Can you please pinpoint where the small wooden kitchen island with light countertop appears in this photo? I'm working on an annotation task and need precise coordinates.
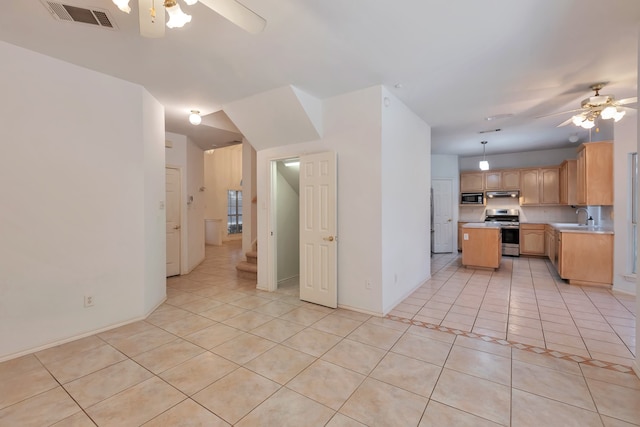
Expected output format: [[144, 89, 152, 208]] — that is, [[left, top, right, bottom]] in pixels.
[[462, 222, 502, 269]]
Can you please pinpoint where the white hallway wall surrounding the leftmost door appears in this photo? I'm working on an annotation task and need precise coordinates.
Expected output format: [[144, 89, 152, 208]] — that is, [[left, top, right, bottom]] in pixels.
[[165, 132, 206, 274]]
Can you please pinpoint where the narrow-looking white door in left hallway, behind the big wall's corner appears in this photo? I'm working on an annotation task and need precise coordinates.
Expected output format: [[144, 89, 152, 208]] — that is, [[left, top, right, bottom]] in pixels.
[[165, 168, 181, 277]]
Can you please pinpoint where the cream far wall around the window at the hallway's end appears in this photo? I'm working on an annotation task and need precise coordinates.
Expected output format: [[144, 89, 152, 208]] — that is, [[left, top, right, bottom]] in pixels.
[[204, 144, 242, 240]]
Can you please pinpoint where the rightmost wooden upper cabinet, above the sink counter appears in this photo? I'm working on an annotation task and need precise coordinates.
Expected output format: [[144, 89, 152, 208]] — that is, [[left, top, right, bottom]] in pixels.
[[576, 141, 613, 206]]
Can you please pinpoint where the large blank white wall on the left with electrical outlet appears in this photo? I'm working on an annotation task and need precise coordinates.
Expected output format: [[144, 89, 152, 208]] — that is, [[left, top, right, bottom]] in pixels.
[[0, 42, 166, 360]]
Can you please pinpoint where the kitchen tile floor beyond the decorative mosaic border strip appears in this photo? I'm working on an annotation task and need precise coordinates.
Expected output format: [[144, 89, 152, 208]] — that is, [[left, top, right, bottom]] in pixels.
[[389, 254, 636, 366]]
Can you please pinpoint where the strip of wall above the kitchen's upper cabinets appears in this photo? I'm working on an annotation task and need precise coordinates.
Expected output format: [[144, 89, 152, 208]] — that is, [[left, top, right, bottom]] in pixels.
[[459, 147, 580, 171]]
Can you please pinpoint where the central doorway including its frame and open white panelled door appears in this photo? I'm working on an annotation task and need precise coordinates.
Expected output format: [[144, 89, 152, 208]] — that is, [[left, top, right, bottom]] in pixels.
[[267, 152, 338, 308]]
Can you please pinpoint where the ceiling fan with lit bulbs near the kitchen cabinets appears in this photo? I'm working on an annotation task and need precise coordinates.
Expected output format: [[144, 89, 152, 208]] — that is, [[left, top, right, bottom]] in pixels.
[[540, 83, 638, 129]]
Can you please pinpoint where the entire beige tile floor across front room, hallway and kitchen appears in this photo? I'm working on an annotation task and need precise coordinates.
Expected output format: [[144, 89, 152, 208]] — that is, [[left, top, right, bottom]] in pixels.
[[0, 243, 640, 427]]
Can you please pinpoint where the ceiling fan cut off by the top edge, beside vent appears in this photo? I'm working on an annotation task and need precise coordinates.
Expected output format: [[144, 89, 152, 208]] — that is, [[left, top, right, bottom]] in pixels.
[[112, 0, 267, 38]]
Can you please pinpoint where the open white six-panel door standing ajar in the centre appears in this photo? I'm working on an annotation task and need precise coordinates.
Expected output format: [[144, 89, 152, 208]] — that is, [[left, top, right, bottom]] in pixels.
[[300, 152, 338, 308]]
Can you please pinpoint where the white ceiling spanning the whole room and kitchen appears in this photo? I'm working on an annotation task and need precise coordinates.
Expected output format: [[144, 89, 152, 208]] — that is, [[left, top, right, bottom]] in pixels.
[[0, 0, 640, 156]]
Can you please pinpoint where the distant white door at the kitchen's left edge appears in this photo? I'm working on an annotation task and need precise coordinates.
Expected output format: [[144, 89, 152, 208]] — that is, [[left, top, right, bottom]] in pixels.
[[431, 179, 453, 253]]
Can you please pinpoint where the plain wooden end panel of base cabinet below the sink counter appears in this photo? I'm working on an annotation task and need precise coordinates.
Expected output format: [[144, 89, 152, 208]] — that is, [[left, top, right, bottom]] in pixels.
[[557, 232, 613, 285]]
